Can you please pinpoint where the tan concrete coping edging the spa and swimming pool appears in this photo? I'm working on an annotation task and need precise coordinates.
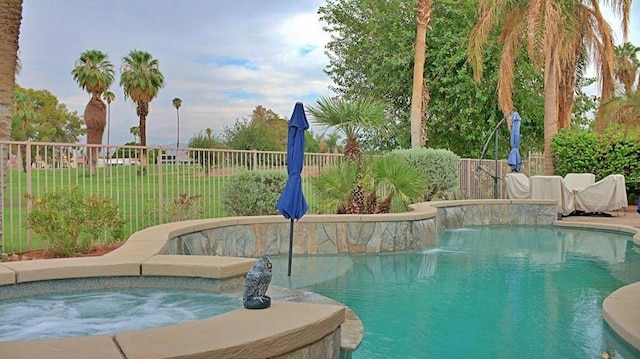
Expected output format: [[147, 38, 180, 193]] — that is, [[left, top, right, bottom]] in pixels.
[[0, 200, 640, 359]]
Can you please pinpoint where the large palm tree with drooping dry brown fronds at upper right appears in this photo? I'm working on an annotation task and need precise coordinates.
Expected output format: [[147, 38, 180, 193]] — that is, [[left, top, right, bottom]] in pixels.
[[468, 0, 630, 174]]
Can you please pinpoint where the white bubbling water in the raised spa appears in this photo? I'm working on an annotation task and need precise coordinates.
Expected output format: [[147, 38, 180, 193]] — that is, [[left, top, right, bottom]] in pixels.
[[0, 289, 242, 342]]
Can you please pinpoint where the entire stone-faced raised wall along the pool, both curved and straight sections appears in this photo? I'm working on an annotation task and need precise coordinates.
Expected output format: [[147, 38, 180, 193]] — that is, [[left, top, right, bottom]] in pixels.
[[165, 200, 556, 257]]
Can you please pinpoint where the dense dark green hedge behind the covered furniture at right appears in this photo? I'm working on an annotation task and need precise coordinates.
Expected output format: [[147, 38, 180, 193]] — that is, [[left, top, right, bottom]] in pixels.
[[552, 126, 640, 197]]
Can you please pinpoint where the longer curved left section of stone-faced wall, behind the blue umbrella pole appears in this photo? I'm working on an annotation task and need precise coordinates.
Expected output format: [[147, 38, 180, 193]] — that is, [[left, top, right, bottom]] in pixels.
[[166, 218, 436, 257]]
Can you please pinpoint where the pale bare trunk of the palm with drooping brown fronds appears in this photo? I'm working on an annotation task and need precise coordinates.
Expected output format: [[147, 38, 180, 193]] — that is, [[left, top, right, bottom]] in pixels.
[[544, 49, 558, 176]]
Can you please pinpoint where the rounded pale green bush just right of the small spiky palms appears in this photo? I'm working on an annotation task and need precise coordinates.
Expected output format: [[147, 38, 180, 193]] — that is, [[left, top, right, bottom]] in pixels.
[[389, 148, 460, 201]]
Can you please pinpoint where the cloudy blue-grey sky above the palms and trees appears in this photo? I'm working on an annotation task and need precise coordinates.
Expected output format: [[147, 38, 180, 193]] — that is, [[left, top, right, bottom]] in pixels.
[[16, 0, 640, 146]]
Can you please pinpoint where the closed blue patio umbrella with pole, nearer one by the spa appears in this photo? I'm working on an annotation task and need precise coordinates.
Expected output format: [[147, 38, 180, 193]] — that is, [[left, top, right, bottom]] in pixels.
[[276, 102, 309, 276]]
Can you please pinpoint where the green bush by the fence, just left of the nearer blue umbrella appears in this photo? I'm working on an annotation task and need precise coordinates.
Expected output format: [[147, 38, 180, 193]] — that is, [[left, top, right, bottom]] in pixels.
[[222, 171, 287, 216]]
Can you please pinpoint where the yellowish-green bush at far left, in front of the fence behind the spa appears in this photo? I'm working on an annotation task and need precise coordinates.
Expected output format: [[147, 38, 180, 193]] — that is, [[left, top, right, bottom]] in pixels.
[[27, 187, 124, 257]]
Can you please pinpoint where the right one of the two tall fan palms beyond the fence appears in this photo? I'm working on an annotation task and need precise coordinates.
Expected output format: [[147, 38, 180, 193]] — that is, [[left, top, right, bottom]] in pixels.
[[120, 50, 164, 165]]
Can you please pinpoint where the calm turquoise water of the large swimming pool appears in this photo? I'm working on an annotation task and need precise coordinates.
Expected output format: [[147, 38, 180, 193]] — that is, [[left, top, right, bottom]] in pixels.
[[272, 226, 640, 359]]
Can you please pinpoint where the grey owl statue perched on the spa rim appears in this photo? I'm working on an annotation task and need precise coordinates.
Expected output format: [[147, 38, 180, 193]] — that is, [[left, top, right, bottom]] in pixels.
[[242, 256, 271, 309]]
